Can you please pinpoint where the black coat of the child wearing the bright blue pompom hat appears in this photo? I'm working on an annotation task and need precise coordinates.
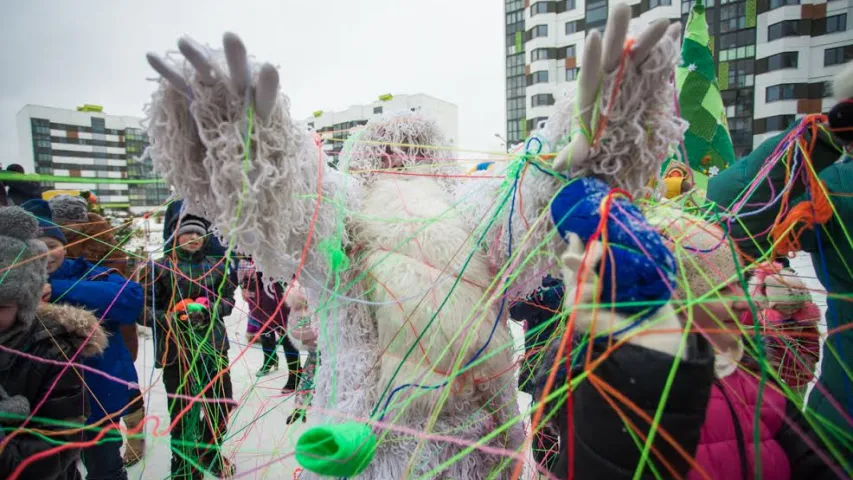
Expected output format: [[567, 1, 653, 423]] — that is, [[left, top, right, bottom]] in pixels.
[[534, 335, 714, 480]]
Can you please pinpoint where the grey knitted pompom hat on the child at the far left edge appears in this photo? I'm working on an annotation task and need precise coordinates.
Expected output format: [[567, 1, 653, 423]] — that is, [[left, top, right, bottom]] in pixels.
[[0, 206, 47, 327]]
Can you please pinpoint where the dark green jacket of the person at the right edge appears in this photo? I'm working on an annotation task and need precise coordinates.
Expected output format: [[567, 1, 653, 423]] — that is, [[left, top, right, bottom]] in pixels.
[[707, 126, 853, 451]]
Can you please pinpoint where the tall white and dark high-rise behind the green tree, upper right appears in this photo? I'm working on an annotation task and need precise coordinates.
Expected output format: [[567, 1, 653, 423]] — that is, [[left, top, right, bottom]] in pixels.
[[505, 0, 853, 156]]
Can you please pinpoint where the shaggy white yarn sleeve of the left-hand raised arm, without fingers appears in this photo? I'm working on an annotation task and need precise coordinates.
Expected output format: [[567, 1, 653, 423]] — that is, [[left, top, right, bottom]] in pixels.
[[148, 53, 357, 281]]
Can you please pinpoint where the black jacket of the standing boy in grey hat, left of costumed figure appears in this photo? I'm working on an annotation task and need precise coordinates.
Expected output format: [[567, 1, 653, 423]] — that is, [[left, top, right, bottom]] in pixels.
[[142, 248, 237, 368]]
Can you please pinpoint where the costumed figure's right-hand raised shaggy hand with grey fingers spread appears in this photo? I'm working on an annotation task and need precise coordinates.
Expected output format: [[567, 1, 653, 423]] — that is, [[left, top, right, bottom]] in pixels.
[[554, 4, 685, 194]]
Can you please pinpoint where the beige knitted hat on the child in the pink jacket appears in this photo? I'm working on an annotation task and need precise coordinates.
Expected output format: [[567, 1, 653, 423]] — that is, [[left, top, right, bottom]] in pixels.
[[646, 205, 740, 300]]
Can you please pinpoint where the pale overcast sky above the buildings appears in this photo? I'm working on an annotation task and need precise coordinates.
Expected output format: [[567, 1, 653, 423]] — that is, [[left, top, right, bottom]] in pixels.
[[0, 0, 506, 165]]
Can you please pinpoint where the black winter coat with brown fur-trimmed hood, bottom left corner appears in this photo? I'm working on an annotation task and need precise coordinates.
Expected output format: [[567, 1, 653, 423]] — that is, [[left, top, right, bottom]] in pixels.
[[0, 304, 107, 480]]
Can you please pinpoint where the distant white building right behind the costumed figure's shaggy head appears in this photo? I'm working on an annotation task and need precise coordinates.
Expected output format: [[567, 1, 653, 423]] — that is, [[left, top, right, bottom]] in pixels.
[[305, 93, 459, 164]]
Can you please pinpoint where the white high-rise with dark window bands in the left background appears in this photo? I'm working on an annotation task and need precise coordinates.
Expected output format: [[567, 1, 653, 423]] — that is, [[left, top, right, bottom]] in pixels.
[[17, 105, 169, 213]]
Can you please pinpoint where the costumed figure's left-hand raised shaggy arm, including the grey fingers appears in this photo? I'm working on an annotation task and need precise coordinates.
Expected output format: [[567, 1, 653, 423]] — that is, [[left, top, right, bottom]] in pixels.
[[147, 33, 342, 281]]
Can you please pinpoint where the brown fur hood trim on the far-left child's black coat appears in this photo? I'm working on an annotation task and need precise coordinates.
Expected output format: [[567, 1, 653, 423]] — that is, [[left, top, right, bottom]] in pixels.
[[33, 303, 108, 357]]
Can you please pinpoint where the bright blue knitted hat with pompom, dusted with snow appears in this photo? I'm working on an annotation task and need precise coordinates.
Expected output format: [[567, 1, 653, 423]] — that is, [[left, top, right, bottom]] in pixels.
[[551, 177, 677, 316]]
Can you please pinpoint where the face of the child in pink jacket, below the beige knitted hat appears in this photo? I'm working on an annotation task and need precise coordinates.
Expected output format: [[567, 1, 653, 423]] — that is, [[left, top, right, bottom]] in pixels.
[[690, 281, 749, 348]]
